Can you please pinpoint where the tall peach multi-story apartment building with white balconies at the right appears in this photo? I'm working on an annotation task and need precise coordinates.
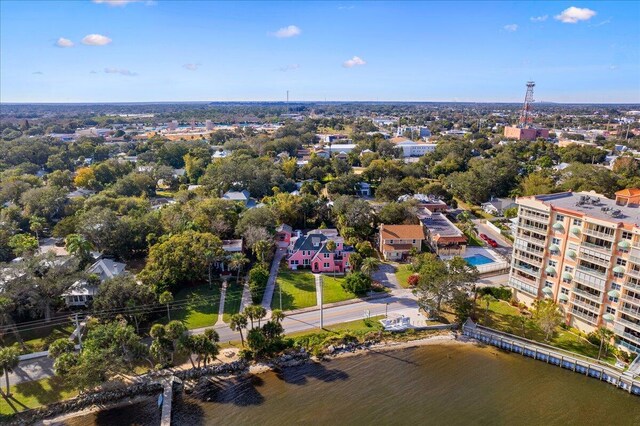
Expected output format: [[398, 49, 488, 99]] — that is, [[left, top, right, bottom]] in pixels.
[[509, 189, 640, 353]]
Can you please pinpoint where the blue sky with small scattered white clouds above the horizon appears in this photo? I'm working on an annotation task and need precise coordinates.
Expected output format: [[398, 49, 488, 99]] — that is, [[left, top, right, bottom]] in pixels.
[[0, 0, 640, 103]]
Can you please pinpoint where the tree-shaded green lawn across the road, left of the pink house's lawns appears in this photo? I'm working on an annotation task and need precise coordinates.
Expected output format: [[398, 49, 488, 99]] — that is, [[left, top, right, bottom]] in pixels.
[[162, 282, 220, 330]]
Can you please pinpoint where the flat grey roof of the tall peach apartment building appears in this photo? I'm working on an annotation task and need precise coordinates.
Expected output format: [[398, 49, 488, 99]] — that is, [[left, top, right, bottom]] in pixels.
[[525, 192, 640, 226]]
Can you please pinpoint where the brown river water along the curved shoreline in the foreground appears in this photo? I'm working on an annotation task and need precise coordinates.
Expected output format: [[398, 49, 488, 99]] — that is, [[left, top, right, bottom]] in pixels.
[[66, 345, 640, 426]]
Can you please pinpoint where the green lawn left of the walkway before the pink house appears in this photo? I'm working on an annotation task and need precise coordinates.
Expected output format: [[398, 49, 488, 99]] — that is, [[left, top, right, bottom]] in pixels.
[[271, 269, 316, 311]]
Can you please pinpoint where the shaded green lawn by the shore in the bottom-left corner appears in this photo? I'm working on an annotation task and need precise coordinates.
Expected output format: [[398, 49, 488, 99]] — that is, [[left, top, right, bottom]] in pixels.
[[0, 377, 78, 416]]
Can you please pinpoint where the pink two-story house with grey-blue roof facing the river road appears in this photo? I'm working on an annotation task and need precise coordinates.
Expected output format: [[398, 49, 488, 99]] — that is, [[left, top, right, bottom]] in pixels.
[[287, 229, 353, 273]]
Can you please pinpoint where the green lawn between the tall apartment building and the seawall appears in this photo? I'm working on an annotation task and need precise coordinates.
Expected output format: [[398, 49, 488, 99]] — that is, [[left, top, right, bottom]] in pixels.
[[478, 301, 615, 364]]
